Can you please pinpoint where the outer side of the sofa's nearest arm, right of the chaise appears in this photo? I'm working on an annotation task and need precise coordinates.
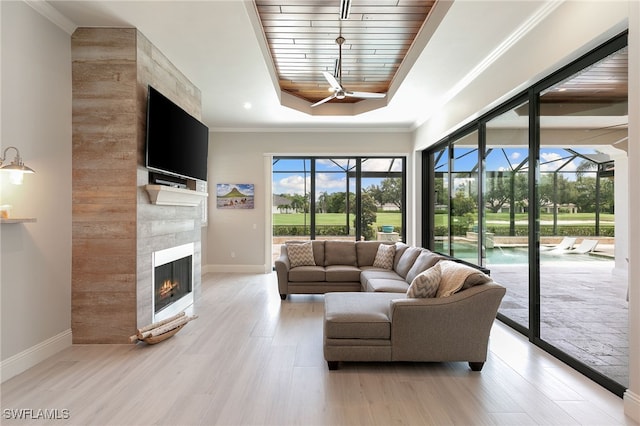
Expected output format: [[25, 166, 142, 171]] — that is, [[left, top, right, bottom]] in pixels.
[[390, 282, 506, 362]]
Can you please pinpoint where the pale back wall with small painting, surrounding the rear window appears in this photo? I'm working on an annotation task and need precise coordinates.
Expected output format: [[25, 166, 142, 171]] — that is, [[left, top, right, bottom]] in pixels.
[[208, 131, 413, 272]]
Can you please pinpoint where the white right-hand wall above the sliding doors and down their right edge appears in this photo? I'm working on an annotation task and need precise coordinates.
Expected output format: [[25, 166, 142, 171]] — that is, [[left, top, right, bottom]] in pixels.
[[414, 0, 640, 421]]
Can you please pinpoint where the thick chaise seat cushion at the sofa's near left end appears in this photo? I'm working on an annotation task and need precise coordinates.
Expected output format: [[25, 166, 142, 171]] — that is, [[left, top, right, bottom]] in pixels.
[[324, 293, 394, 339]]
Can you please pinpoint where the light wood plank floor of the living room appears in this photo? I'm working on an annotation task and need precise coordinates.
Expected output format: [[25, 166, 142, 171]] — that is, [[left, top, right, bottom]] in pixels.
[[0, 274, 636, 425]]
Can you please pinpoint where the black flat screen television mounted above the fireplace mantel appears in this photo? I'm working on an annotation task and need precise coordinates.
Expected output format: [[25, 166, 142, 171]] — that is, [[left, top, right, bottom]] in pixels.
[[146, 86, 209, 181]]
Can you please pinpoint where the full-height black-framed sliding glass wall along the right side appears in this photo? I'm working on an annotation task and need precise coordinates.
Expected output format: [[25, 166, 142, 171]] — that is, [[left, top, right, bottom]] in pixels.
[[423, 34, 629, 395]]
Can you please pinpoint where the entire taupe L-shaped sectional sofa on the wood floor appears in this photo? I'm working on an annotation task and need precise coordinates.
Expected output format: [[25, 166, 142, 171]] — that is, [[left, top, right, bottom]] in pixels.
[[276, 241, 506, 371]]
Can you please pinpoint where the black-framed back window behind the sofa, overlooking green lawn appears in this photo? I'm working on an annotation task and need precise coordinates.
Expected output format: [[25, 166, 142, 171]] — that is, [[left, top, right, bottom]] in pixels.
[[272, 157, 406, 256]]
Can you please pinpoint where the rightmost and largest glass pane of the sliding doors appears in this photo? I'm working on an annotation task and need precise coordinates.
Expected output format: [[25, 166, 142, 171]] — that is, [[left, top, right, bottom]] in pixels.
[[538, 48, 629, 386]]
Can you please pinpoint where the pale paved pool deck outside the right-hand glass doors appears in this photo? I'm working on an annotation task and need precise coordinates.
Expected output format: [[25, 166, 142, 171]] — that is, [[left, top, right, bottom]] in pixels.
[[488, 255, 629, 386]]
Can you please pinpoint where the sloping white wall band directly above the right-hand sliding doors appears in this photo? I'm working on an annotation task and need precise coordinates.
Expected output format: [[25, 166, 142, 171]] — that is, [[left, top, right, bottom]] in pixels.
[[415, 0, 633, 149]]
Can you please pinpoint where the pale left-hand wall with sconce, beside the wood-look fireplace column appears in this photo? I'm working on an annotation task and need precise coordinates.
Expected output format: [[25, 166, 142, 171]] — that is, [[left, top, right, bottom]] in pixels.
[[0, 1, 71, 381]]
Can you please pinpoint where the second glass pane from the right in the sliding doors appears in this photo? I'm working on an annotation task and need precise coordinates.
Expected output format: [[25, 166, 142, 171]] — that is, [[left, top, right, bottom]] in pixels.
[[482, 102, 530, 328]]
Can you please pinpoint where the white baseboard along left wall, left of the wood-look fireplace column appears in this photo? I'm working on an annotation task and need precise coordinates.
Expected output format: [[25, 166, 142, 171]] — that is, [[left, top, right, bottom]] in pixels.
[[0, 329, 73, 382]]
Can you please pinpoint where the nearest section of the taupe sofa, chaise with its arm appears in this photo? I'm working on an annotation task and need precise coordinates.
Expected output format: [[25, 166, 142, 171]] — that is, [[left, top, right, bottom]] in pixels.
[[323, 282, 506, 371]]
